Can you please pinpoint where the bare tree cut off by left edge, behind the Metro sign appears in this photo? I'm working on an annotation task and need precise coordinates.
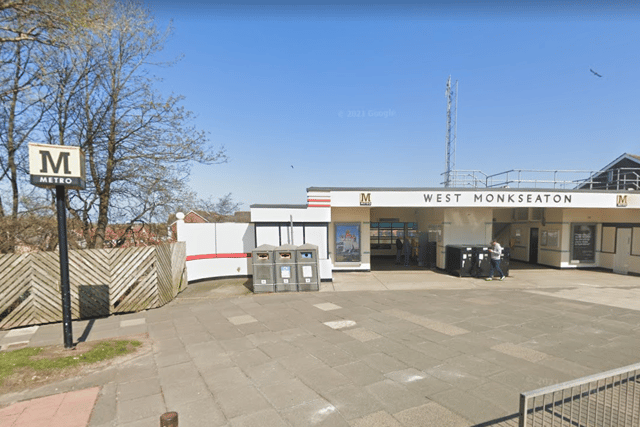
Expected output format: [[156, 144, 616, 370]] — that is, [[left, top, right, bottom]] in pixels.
[[0, 0, 104, 252]]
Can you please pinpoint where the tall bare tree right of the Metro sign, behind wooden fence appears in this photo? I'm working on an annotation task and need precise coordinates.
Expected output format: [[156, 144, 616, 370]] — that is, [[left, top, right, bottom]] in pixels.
[[47, 2, 226, 248]]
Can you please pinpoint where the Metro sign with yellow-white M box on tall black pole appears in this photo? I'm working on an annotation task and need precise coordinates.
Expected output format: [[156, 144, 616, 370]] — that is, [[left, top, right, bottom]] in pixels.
[[29, 144, 85, 349]]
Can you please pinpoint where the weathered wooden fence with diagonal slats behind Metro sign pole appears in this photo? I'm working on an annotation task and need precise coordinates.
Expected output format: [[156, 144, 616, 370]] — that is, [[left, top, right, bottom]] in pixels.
[[0, 242, 187, 329]]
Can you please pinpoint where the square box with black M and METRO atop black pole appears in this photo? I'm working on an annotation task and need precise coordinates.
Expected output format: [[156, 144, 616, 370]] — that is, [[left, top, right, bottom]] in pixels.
[[29, 144, 85, 189]]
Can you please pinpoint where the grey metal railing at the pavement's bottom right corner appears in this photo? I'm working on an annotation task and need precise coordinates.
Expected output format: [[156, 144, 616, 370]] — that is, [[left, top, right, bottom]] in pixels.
[[519, 363, 640, 427]]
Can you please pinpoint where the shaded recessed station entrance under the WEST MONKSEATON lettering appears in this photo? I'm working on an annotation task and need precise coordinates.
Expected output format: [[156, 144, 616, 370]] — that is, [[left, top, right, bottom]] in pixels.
[[363, 207, 568, 270]]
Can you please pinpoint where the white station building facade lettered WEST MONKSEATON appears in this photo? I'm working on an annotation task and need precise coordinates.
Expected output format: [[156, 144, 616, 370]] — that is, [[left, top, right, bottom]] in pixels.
[[251, 187, 640, 280]]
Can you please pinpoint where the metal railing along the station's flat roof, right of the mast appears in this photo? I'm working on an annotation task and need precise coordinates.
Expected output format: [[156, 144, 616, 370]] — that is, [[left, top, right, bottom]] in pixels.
[[440, 168, 640, 191]]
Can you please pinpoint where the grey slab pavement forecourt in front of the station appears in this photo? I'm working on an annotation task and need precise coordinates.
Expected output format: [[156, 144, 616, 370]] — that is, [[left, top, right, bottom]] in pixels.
[[0, 266, 640, 427]]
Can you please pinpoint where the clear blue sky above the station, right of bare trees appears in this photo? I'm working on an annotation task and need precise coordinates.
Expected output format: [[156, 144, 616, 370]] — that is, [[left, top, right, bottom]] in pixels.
[[147, 0, 640, 209]]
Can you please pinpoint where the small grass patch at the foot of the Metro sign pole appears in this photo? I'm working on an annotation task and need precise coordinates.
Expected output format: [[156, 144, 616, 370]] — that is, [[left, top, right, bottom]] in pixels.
[[0, 340, 142, 389]]
